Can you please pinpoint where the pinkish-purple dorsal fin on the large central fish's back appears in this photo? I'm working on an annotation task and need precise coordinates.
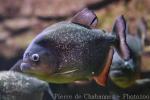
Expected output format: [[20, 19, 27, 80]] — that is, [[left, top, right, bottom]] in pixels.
[[71, 8, 98, 28]]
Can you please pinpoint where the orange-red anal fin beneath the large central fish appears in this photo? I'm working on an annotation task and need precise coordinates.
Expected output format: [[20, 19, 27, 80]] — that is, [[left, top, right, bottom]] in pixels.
[[94, 49, 114, 86]]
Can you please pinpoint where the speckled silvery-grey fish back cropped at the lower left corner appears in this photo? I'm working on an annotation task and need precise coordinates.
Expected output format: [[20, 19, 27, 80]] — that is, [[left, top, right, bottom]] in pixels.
[[0, 71, 51, 100]]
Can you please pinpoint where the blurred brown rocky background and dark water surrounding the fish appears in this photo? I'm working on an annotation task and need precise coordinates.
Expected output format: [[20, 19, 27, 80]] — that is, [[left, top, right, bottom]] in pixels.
[[0, 0, 150, 100]]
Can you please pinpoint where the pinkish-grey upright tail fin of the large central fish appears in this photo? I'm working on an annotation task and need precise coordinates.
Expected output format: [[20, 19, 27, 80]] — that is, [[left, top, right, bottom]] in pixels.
[[113, 15, 130, 60]]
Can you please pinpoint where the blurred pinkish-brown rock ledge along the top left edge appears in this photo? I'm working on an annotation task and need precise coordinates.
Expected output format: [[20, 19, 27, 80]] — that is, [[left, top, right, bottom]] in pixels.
[[0, 0, 103, 17]]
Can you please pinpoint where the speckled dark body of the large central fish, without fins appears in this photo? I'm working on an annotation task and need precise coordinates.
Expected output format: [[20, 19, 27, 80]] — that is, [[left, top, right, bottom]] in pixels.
[[21, 22, 116, 83]]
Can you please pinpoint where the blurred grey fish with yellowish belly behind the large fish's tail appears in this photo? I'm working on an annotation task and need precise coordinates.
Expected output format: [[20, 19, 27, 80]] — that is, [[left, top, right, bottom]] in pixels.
[[109, 27, 143, 88]]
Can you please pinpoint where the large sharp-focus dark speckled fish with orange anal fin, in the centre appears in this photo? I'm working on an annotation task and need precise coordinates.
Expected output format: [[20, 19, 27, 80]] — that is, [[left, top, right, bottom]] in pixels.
[[11, 8, 130, 86]]
